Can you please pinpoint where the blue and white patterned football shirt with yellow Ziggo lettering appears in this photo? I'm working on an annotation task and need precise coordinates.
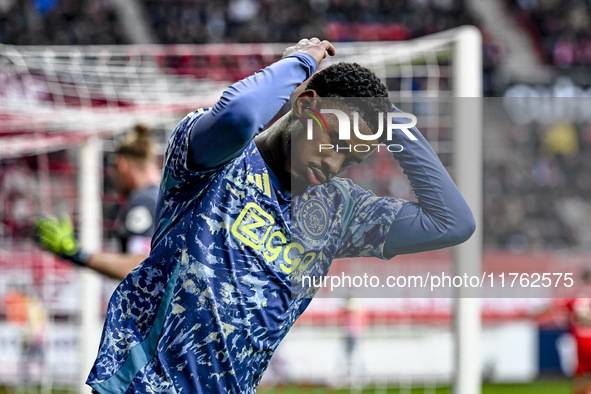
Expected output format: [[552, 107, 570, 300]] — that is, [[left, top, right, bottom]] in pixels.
[[87, 54, 476, 394]]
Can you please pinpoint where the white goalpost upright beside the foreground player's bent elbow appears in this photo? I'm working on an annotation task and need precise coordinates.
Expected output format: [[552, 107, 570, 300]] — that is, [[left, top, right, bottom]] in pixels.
[[453, 28, 483, 394]]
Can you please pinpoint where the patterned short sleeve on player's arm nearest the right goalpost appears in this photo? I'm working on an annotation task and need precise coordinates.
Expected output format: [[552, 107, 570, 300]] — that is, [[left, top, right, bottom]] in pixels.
[[336, 180, 407, 260]]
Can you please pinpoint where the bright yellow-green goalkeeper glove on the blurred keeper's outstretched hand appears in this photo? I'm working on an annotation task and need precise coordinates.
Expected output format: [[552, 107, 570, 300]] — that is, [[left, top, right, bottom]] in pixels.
[[34, 215, 91, 266]]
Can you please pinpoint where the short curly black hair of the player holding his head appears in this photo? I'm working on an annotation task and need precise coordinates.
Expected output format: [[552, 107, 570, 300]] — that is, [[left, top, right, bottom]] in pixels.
[[307, 62, 392, 136]]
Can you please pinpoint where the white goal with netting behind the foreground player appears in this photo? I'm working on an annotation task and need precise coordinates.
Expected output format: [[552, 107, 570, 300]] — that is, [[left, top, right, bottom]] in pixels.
[[0, 28, 482, 393]]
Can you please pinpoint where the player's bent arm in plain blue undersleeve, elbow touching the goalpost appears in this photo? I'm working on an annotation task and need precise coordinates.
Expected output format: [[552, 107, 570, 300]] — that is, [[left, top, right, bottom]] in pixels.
[[384, 109, 476, 258]]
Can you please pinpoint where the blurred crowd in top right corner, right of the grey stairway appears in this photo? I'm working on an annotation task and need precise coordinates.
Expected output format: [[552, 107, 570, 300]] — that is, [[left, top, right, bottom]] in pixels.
[[508, 0, 591, 67]]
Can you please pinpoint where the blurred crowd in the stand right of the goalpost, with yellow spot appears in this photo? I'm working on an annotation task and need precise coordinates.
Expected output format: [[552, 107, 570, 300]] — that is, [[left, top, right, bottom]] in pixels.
[[484, 123, 591, 251]]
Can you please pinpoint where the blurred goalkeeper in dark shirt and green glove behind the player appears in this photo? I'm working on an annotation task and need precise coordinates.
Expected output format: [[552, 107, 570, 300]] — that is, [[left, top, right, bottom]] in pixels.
[[34, 125, 160, 280]]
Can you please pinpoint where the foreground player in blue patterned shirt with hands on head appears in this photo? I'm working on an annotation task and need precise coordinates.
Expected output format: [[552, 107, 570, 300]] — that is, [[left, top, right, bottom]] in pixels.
[[87, 38, 475, 394]]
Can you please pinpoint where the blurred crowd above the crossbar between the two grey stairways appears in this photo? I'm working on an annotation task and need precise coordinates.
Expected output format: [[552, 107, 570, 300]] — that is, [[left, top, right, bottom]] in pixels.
[[145, 0, 475, 44]]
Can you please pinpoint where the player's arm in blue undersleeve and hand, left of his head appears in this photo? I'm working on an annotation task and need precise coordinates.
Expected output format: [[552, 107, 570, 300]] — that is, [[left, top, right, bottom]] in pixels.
[[188, 38, 335, 170]]
